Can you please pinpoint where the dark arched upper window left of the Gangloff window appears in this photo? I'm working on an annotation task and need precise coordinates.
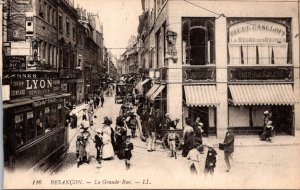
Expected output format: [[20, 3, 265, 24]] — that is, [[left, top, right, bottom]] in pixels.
[[182, 18, 215, 65]]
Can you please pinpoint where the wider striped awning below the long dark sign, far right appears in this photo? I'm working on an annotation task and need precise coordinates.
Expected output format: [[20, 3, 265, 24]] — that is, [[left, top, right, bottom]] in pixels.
[[229, 84, 296, 106]]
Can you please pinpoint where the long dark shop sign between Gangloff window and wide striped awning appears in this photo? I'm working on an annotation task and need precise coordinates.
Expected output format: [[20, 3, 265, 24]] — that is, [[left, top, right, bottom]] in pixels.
[[228, 67, 293, 81]]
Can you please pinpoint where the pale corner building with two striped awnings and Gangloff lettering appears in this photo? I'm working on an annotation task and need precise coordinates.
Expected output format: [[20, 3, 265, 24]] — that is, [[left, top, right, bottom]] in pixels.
[[142, 0, 300, 137]]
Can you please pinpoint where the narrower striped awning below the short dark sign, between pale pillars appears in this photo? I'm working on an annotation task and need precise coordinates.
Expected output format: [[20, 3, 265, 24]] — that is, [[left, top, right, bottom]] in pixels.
[[184, 85, 218, 107]]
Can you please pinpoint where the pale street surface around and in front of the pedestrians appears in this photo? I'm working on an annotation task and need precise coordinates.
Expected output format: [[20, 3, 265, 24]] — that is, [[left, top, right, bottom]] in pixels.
[[49, 93, 300, 188]]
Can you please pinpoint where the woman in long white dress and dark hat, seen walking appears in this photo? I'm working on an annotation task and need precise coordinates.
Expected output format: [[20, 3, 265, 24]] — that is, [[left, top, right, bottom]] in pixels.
[[103, 119, 115, 160]]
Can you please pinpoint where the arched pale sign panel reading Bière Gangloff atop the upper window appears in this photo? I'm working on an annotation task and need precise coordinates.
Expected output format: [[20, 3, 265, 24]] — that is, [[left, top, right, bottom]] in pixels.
[[229, 20, 287, 44]]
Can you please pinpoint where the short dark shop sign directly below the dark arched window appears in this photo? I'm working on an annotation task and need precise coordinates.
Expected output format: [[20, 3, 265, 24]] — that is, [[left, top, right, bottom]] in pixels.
[[183, 68, 216, 82]]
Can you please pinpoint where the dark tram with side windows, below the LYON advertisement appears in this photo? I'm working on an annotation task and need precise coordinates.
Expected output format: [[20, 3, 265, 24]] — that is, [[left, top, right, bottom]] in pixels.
[[3, 93, 70, 171]]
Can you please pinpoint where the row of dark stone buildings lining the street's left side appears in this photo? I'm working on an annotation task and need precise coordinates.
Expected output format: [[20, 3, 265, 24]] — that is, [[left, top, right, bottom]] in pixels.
[[3, 0, 116, 104]]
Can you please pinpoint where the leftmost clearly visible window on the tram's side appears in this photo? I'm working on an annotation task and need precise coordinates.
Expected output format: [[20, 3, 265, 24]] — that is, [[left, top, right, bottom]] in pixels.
[[15, 114, 26, 147]]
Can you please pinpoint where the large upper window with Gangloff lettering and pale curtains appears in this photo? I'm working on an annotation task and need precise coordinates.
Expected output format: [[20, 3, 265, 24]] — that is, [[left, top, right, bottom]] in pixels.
[[228, 19, 292, 65]]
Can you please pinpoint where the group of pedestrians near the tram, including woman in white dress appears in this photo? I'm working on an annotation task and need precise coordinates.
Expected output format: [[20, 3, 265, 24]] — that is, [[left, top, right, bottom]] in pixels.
[[76, 117, 133, 169]]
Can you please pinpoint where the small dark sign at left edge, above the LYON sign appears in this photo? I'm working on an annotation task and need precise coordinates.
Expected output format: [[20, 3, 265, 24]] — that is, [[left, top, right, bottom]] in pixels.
[[3, 56, 26, 70]]
